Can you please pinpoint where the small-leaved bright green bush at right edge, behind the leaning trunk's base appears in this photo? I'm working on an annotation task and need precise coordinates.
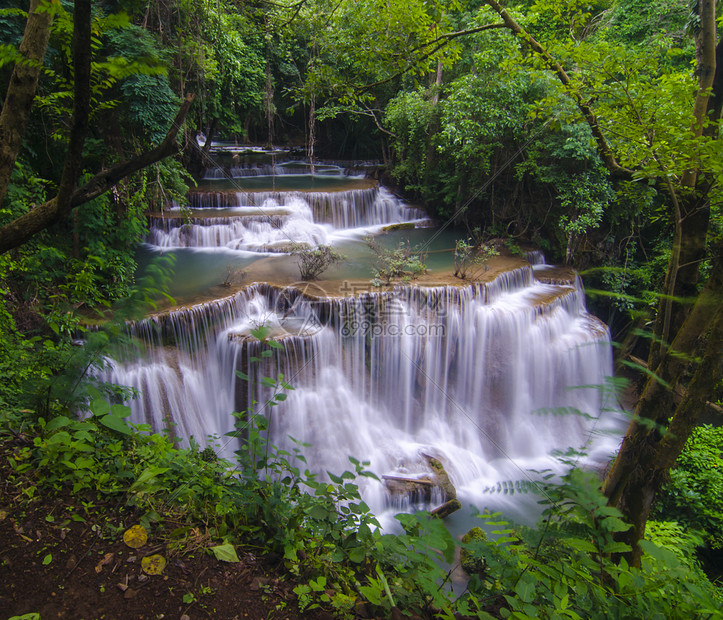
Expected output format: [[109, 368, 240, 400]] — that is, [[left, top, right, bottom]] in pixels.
[[655, 424, 723, 549]]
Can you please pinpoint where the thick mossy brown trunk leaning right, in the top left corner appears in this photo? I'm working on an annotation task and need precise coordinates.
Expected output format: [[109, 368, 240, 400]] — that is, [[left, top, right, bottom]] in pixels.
[[0, 0, 53, 208]]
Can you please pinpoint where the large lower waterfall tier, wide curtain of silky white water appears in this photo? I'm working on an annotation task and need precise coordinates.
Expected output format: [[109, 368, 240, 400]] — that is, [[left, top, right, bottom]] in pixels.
[[103, 267, 614, 513]]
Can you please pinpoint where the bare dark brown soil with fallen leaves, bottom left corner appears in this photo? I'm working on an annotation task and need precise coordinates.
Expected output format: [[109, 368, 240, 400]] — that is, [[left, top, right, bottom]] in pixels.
[[0, 451, 333, 620]]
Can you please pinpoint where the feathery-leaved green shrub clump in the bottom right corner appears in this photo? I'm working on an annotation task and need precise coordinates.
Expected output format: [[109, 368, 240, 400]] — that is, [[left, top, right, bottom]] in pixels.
[[450, 470, 721, 618]]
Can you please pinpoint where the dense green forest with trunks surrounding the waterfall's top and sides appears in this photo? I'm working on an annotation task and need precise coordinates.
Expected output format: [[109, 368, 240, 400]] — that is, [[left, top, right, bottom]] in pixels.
[[0, 0, 723, 616]]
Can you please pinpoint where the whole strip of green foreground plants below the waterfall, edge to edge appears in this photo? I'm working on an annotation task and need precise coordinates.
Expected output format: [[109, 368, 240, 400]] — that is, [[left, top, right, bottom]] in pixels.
[[0, 328, 721, 619]]
